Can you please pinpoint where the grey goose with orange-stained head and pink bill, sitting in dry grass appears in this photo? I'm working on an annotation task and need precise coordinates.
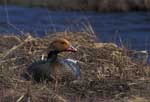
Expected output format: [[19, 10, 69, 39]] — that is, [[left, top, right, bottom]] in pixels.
[[27, 38, 80, 82]]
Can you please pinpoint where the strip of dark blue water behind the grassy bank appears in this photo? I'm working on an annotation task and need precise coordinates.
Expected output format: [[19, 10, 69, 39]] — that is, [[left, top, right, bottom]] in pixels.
[[0, 6, 150, 50]]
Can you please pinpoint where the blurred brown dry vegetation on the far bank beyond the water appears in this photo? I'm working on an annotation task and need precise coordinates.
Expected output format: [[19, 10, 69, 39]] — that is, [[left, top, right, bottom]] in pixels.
[[0, 0, 150, 12]]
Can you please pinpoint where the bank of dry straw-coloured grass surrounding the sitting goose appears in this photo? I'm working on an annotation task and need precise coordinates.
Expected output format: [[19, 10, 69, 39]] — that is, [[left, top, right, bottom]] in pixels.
[[0, 32, 150, 102]]
